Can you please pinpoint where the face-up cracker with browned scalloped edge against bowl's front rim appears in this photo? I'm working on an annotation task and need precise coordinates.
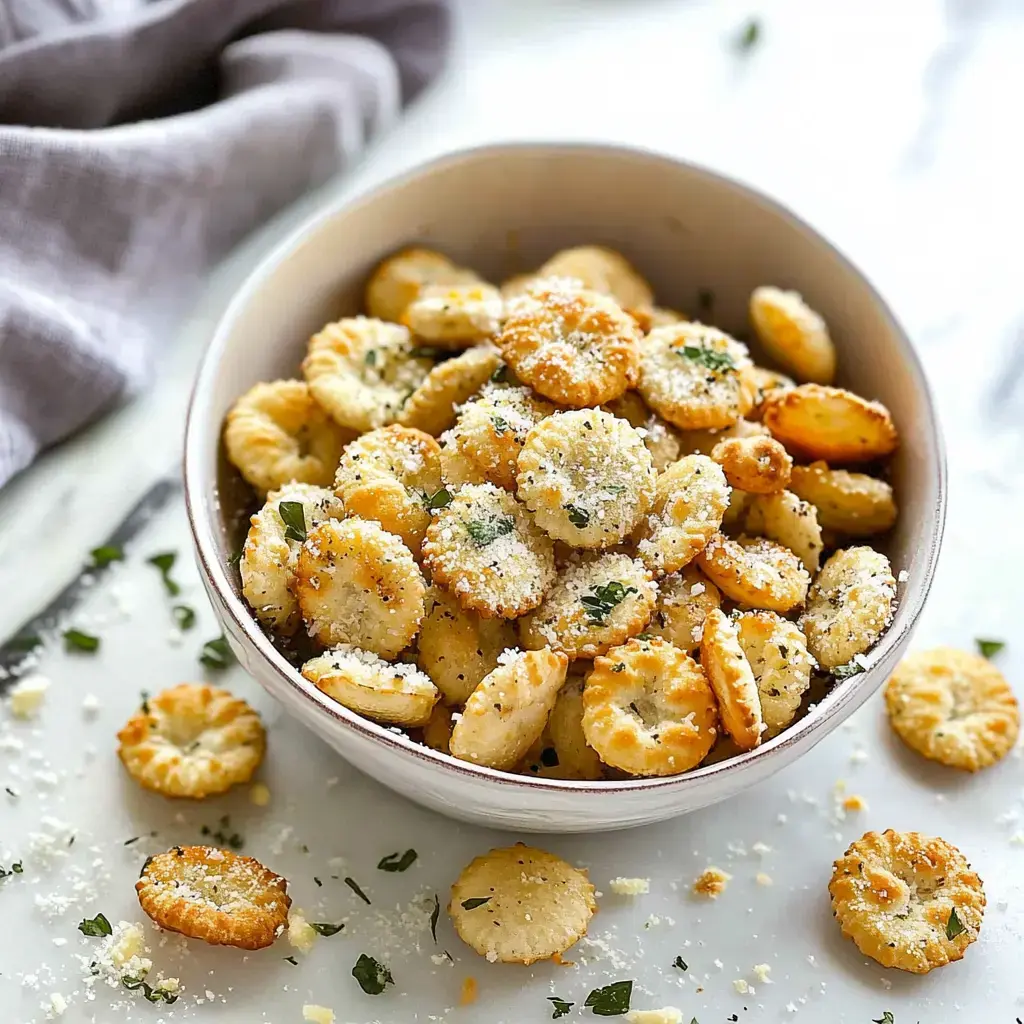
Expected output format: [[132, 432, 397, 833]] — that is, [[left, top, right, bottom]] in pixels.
[[583, 637, 718, 775]]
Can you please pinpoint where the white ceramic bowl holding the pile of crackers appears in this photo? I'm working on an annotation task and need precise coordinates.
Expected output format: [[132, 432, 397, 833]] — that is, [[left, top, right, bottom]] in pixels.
[[184, 144, 945, 831]]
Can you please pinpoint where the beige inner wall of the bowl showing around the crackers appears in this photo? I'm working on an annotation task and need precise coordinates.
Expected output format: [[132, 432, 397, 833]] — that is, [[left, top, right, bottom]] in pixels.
[[186, 145, 943, 781]]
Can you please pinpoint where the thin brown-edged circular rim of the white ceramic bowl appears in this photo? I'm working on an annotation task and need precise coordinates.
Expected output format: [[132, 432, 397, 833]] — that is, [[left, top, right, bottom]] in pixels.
[[182, 140, 947, 799]]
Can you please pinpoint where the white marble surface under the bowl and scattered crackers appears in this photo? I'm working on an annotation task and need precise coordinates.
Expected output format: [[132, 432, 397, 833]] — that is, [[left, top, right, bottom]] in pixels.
[[0, 0, 1024, 1024]]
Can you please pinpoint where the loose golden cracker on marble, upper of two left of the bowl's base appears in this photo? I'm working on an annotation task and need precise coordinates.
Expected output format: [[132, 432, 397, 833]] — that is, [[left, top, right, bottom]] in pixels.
[[118, 683, 266, 800]]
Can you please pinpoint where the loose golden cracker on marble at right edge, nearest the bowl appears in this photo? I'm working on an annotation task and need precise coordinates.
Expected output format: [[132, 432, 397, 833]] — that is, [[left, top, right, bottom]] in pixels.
[[886, 647, 1020, 771]]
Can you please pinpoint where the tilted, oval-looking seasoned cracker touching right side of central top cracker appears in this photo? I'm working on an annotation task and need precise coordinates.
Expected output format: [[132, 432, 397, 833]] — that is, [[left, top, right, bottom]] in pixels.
[[637, 455, 729, 575]]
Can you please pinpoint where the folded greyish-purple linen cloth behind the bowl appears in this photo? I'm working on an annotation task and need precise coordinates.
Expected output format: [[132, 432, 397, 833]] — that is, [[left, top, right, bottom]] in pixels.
[[0, 0, 450, 485]]
